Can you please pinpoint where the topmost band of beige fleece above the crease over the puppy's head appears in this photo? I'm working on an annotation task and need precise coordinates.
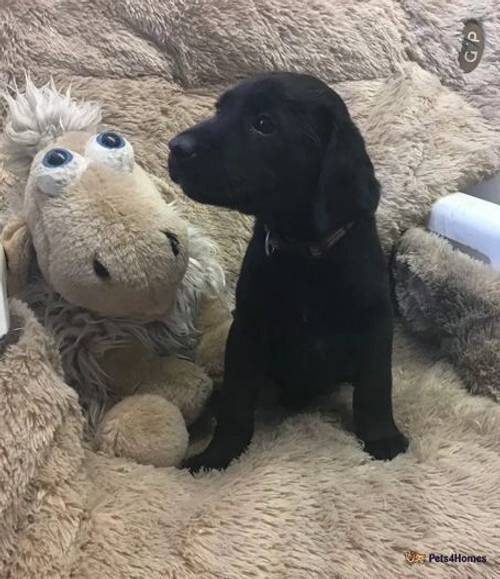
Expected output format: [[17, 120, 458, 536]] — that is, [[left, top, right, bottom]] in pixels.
[[0, 0, 500, 126]]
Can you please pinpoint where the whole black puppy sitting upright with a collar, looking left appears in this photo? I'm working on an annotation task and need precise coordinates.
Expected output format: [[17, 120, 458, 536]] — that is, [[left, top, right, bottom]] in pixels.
[[169, 73, 408, 471]]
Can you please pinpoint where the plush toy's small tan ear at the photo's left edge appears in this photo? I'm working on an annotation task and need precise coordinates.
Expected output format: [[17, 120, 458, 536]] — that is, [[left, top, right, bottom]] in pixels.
[[0, 218, 34, 296]]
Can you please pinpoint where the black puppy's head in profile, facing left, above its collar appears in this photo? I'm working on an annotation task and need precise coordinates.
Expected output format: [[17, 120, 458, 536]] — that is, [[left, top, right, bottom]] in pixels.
[[169, 73, 379, 232]]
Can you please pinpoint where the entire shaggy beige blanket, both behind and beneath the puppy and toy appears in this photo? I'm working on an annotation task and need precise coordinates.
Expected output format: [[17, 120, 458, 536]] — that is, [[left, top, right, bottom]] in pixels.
[[0, 0, 500, 579]]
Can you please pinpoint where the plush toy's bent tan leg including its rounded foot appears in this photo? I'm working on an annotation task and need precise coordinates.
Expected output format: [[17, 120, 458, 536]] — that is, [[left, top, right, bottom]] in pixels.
[[96, 344, 212, 466]]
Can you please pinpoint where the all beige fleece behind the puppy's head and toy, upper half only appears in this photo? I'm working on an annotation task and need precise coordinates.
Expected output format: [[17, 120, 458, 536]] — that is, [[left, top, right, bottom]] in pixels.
[[0, 0, 500, 260]]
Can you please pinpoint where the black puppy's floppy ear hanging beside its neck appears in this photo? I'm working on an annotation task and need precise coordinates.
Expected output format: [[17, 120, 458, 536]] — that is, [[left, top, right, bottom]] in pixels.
[[314, 93, 380, 234]]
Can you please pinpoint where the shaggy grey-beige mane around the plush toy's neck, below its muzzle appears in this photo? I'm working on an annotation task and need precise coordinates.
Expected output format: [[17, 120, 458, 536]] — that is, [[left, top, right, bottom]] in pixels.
[[23, 226, 225, 425]]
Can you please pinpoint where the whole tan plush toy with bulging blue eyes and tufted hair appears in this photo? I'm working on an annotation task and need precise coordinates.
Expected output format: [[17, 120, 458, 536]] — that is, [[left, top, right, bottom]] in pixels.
[[0, 79, 231, 466]]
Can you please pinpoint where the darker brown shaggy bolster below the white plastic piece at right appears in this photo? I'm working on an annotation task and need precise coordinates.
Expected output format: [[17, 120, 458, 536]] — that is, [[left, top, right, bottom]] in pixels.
[[394, 228, 500, 402]]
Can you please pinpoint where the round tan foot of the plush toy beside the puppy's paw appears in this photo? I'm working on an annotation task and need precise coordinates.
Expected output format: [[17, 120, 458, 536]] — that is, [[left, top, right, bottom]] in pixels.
[[96, 394, 189, 466]]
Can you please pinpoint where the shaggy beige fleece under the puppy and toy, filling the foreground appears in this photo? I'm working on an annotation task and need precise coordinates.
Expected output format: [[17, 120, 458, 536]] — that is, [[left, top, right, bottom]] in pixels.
[[0, 302, 500, 579]]
